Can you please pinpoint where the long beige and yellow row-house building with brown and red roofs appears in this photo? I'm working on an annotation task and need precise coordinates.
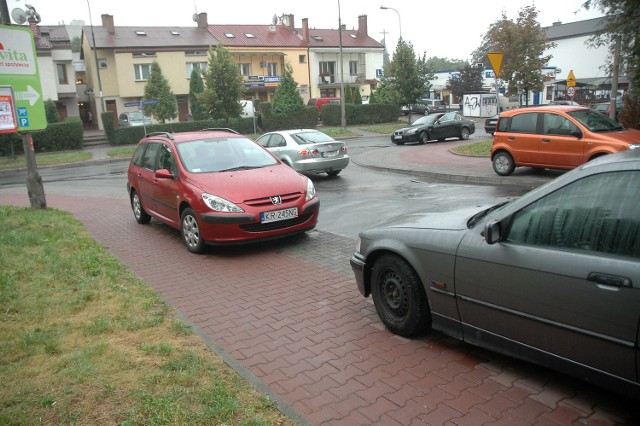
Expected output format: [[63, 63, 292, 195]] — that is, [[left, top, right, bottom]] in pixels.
[[82, 13, 384, 128]]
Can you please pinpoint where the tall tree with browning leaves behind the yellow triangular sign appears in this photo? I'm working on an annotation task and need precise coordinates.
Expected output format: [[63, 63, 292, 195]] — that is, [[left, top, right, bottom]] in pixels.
[[473, 6, 555, 103]]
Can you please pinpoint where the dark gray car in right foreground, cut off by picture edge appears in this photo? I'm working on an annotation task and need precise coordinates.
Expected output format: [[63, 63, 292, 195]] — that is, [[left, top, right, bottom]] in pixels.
[[350, 150, 640, 399]]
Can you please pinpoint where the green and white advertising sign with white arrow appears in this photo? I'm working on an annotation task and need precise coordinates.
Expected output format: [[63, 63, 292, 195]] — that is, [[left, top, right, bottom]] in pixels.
[[0, 25, 47, 132]]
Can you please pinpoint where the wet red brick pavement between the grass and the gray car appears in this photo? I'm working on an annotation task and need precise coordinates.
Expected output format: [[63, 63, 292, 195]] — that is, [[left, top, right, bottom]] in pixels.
[[0, 195, 637, 426]]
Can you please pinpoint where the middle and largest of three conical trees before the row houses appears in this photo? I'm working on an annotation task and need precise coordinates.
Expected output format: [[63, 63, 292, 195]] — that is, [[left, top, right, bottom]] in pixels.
[[198, 43, 244, 124]]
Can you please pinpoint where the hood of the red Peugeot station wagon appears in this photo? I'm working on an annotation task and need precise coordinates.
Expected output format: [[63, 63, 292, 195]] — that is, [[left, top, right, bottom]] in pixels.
[[186, 164, 307, 203]]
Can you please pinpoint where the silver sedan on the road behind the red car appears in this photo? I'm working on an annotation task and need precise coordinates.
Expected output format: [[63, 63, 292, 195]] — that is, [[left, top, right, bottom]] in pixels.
[[256, 129, 349, 176]]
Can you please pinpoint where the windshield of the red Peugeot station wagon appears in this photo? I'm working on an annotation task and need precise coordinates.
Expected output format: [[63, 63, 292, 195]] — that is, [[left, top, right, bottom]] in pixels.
[[177, 138, 278, 173]]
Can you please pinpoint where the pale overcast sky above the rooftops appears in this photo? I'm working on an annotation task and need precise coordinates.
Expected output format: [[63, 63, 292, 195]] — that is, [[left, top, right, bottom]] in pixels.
[[7, 0, 601, 60]]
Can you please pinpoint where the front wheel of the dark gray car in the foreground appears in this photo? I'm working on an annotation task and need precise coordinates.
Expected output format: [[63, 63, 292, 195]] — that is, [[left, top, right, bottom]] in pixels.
[[371, 254, 431, 337]]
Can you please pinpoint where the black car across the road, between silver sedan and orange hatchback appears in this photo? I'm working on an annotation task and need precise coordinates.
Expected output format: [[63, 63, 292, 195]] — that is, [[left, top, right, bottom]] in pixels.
[[391, 112, 476, 145]]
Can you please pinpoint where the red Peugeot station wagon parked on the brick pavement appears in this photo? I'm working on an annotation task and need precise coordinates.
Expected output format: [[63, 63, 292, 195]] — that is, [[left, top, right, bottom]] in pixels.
[[127, 129, 320, 253]]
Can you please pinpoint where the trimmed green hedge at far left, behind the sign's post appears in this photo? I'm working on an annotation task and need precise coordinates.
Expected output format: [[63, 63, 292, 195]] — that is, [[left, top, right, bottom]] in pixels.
[[0, 117, 83, 156]]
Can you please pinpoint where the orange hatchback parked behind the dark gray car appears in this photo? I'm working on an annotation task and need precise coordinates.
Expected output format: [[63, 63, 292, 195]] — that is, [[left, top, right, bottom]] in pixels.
[[491, 105, 640, 176]]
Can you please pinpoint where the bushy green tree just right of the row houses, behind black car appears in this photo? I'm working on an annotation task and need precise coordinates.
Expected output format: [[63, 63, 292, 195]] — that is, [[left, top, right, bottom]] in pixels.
[[384, 39, 433, 105]]
